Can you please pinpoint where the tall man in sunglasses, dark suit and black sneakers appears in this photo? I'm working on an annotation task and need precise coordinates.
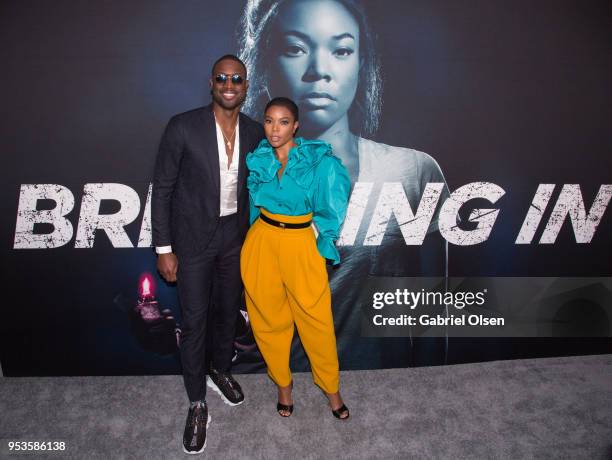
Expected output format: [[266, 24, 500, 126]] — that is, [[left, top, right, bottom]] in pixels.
[[151, 55, 264, 453]]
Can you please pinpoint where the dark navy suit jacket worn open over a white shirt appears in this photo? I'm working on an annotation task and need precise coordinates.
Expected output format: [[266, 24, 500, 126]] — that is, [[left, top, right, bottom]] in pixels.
[[151, 104, 264, 257]]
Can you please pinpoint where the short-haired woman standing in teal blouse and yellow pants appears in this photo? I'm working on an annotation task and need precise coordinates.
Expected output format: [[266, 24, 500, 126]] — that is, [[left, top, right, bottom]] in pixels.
[[240, 98, 350, 419]]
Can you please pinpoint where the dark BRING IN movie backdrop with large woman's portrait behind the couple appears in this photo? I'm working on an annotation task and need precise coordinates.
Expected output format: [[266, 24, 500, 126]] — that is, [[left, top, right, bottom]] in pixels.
[[0, 0, 612, 376]]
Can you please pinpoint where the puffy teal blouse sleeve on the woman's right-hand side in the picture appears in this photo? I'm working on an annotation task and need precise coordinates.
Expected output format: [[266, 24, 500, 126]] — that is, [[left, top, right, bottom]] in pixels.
[[313, 155, 351, 265]]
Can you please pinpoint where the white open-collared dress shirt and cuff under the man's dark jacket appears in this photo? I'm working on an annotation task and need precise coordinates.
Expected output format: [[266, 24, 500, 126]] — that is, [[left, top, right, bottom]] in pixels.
[[155, 119, 240, 254]]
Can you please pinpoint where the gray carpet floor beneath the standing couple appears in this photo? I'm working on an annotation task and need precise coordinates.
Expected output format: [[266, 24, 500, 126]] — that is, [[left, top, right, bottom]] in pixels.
[[0, 355, 612, 459]]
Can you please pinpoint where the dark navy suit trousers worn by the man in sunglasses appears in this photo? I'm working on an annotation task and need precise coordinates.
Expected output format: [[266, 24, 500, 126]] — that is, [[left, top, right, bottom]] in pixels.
[[177, 214, 242, 401]]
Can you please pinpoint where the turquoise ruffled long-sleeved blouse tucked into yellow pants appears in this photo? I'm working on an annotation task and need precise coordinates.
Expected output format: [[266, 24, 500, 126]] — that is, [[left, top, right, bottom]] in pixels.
[[246, 137, 351, 265]]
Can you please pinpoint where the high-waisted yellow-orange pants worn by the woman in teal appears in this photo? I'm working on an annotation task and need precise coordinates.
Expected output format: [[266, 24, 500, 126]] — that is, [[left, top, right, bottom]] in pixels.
[[240, 209, 339, 393]]
